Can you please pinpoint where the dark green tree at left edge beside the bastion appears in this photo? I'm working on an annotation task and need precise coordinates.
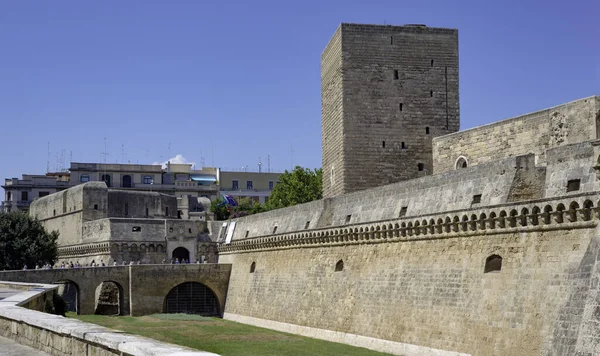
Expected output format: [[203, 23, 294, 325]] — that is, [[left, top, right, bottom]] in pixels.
[[0, 212, 58, 270]]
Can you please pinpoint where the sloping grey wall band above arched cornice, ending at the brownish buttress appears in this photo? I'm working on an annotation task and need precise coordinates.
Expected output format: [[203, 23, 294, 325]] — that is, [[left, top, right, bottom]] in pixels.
[[226, 155, 545, 240]]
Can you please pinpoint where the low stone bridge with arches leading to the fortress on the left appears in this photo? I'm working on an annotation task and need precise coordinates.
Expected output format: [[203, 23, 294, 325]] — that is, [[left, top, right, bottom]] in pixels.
[[0, 264, 231, 316]]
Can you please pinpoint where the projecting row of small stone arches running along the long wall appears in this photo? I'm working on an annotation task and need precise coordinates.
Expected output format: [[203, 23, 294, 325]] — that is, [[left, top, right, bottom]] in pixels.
[[219, 193, 600, 255]]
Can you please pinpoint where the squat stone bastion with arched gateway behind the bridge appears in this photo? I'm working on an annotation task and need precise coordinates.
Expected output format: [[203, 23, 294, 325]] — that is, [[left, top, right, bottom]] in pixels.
[[30, 182, 217, 265]]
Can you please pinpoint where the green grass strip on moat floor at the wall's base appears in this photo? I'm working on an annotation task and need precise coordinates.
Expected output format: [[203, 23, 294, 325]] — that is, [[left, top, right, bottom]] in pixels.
[[67, 313, 394, 356]]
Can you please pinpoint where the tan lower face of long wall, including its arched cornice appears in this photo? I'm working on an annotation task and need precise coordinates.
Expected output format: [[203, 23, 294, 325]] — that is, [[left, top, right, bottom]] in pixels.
[[219, 193, 600, 356]]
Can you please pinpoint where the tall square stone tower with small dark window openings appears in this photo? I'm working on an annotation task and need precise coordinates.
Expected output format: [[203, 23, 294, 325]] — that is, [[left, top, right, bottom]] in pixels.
[[321, 23, 460, 198]]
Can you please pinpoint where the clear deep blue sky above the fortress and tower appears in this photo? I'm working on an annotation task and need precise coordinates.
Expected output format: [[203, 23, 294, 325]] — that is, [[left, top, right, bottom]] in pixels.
[[0, 0, 600, 178]]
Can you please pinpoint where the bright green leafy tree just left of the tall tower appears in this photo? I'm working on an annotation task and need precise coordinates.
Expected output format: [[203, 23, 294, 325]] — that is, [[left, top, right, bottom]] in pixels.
[[267, 166, 323, 209]]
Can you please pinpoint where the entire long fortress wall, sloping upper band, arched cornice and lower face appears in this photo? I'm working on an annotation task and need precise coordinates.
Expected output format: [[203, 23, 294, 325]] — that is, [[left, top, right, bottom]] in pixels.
[[219, 141, 600, 355]]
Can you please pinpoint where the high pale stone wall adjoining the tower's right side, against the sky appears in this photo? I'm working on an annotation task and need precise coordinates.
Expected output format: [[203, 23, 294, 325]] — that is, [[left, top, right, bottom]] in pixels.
[[433, 96, 600, 174]]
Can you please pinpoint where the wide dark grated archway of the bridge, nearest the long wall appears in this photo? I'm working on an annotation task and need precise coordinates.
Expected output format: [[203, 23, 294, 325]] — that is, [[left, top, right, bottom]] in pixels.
[[164, 282, 221, 316]]
